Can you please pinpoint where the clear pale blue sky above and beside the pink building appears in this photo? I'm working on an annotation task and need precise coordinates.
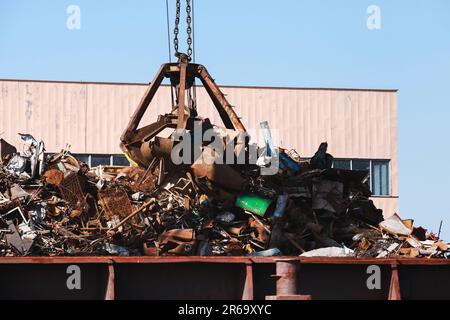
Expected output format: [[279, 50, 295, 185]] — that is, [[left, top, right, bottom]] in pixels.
[[0, 0, 450, 240]]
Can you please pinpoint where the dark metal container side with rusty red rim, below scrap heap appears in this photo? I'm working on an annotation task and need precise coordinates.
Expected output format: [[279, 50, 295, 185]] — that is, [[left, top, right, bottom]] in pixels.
[[0, 257, 450, 300]]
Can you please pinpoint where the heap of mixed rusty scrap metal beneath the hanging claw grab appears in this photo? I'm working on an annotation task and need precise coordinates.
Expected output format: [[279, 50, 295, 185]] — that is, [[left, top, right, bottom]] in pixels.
[[0, 135, 449, 257]]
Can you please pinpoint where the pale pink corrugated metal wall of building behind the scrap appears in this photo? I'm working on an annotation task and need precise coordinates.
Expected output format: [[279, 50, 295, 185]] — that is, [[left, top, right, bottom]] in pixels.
[[0, 80, 398, 213]]
